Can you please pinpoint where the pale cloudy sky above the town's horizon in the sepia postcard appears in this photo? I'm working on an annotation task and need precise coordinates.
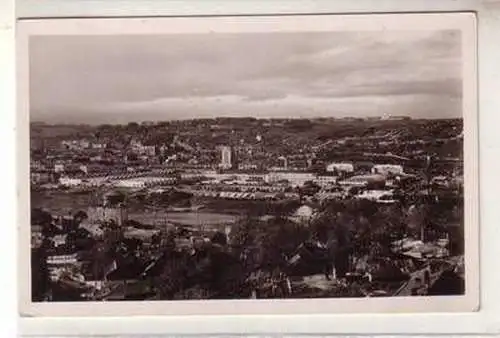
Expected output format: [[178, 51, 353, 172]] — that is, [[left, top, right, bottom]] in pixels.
[[30, 31, 462, 123]]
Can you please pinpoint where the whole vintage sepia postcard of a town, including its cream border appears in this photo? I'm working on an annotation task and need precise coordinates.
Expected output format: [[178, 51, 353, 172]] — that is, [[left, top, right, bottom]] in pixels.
[[17, 13, 479, 316]]
